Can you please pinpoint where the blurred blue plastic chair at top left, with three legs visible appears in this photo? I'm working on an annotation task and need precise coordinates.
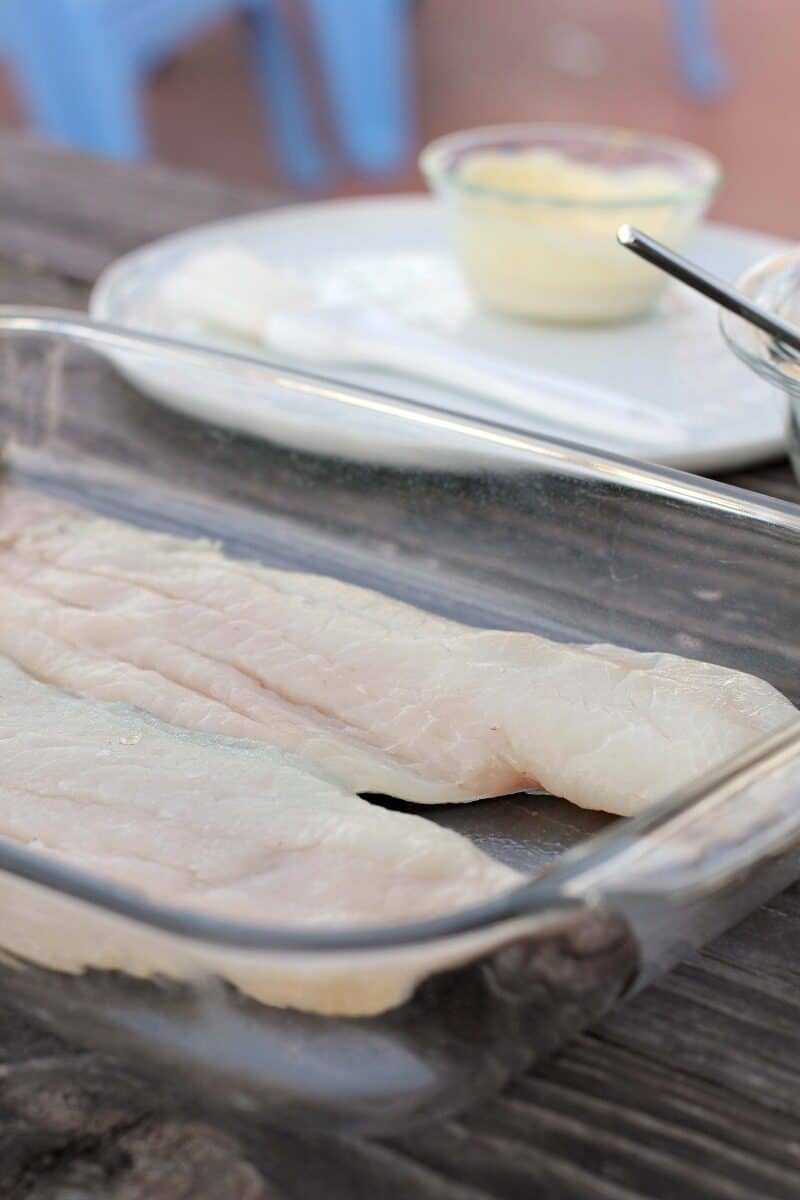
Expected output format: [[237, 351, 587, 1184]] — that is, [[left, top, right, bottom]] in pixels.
[[0, 0, 411, 184]]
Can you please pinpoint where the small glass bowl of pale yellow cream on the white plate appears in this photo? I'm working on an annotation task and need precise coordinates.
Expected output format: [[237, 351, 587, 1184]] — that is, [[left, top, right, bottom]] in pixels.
[[420, 125, 721, 322]]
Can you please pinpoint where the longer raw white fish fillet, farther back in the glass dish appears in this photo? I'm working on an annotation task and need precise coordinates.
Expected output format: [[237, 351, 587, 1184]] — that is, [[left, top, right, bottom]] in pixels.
[[0, 490, 798, 814]]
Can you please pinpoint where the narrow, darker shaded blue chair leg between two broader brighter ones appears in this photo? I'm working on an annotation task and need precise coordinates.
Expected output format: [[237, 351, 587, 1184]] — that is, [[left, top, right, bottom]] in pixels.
[[247, 0, 329, 186]]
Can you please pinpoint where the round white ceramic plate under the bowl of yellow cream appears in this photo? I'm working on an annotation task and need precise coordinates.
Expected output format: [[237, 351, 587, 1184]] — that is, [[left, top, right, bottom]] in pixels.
[[90, 197, 783, 472]]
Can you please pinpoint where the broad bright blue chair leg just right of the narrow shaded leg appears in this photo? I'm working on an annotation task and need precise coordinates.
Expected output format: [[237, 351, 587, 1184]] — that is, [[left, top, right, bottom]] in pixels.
[[306, 0, 411, 173]]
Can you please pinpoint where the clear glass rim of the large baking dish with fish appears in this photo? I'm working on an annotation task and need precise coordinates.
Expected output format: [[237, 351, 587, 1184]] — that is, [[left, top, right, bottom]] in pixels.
[[0, 306, 800, 954]]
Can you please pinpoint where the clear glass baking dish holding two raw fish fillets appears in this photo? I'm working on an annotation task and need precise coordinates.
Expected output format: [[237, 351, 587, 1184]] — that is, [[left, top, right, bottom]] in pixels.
[[0, 310, 800, 1136]]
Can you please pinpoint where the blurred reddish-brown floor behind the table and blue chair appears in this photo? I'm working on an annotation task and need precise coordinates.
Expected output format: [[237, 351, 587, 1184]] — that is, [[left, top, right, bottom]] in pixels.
[[0, 0, 800, 239]]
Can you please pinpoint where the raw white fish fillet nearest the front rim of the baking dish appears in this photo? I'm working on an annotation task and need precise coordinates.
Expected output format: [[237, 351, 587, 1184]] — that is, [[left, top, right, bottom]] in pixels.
[[0, 656, 522, 926]]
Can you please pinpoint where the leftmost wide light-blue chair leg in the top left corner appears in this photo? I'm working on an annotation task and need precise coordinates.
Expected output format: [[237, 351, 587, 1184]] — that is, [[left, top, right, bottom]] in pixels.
[[4, 0, 145, 158]]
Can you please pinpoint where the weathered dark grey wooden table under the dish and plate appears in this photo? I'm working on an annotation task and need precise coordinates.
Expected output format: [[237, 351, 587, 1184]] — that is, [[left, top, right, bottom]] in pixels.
[[0, 136, 800, 1200]]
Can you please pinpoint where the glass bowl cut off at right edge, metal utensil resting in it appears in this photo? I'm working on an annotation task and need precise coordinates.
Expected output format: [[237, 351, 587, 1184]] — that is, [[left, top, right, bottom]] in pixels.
[[720, 246, 800, 480]]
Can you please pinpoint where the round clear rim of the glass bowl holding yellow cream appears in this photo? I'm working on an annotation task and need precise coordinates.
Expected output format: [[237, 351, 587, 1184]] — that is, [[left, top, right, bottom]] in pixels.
[[417, 122, 723, 211]]
